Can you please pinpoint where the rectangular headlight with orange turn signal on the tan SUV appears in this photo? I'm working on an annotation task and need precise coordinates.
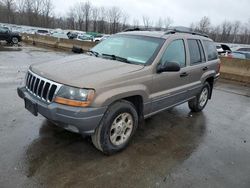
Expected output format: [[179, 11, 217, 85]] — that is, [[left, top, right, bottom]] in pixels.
[[54, 86, 95, 107]]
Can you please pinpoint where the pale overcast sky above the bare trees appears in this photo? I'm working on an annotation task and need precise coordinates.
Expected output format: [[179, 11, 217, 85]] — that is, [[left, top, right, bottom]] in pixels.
[[53, 0, 250, 26]]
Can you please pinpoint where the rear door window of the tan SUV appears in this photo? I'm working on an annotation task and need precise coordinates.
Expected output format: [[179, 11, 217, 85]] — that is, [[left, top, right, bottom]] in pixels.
[[187, 39, 205, 65]]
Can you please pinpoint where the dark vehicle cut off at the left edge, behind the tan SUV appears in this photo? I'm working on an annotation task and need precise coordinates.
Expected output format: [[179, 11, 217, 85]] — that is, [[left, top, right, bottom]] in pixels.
[[0, 26, 22, 44]]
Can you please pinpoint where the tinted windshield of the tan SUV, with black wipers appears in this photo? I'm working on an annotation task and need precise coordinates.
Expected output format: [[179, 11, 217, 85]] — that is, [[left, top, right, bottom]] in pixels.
[[91, 35, 164, 64]]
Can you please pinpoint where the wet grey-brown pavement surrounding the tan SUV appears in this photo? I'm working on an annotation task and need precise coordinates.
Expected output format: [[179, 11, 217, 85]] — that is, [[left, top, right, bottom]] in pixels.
[[0, 47, 250, 188]]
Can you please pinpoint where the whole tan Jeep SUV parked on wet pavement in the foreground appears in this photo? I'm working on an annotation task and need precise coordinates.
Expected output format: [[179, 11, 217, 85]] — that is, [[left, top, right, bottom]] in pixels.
[[18, 30, 220, 154]]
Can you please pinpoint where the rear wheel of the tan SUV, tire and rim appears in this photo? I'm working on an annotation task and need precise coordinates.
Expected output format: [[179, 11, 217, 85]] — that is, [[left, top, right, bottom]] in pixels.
[[188, 82, 211, 112]]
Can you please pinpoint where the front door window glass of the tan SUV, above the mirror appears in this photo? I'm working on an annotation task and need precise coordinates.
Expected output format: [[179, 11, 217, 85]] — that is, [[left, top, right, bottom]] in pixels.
[[161, 39, 186, 68]]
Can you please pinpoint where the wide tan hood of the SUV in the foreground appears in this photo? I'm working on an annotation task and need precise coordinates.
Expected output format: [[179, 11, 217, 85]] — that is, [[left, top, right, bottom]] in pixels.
[[30, 54, 144, 88]]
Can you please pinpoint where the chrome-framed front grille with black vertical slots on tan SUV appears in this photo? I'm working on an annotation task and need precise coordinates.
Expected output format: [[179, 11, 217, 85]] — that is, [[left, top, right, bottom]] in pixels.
[[26, 71, 61, 103]]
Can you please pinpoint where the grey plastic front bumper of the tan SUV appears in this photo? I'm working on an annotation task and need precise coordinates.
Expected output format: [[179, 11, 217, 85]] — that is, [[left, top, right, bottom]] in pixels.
[[17, 87, 107, 135]]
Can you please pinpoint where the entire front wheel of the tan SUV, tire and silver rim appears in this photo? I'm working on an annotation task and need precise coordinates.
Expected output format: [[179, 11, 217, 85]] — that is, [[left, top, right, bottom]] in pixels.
[[91, 100, 138, 155]]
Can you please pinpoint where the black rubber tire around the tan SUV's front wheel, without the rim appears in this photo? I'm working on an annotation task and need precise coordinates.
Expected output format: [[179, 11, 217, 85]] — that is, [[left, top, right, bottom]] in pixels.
[[100, 102, 138, 154]]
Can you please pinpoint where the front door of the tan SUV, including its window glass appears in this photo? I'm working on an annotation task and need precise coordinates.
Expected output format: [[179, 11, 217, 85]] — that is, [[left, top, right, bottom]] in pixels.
[[152, 37, 192, 113]]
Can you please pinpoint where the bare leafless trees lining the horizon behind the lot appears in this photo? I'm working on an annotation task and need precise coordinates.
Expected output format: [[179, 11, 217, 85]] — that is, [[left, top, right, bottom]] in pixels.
[[0, 0, 250, 44]]
